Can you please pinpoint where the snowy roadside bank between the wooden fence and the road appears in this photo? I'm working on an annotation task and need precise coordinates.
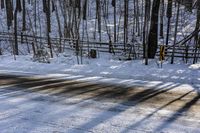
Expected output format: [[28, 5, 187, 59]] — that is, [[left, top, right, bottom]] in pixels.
[[0, 54, 200, 98]]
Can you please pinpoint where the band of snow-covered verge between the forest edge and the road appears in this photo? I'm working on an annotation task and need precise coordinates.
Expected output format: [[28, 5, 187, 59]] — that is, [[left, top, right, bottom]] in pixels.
[[0, 54, 200, 84]]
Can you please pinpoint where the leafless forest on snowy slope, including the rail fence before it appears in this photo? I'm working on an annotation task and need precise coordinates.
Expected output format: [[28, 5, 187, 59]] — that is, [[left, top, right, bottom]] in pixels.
[[0, 0, 200, 65]]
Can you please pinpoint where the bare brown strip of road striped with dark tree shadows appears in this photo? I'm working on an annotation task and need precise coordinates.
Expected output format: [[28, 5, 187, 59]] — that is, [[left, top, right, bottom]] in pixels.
[[0, 75, 200, 132]]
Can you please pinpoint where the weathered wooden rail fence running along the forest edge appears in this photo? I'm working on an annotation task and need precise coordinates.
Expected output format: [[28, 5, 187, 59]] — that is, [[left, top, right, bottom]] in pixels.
[[0, 32, 200, 59]]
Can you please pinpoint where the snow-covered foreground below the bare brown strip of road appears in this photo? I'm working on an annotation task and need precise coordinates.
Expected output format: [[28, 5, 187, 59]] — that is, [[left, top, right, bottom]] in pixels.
[[0, 75, 200, 133]]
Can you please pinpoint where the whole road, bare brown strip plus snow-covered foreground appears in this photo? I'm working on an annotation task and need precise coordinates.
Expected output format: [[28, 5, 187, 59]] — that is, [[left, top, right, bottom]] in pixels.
[[0, 74, 200, 133]]
